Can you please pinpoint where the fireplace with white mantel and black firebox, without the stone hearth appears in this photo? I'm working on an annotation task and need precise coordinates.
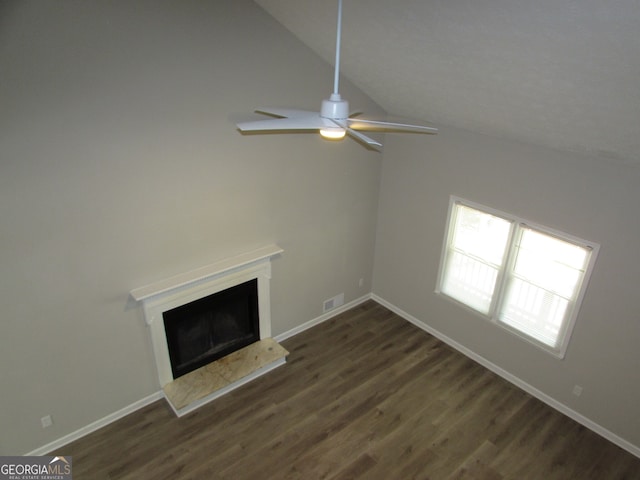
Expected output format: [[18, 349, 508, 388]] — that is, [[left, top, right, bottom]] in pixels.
[[131, 245, 283, 388]]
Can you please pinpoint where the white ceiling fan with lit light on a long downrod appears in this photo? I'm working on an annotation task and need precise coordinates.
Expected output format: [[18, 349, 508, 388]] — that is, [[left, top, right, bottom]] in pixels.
[[237, 0, 438, 148]]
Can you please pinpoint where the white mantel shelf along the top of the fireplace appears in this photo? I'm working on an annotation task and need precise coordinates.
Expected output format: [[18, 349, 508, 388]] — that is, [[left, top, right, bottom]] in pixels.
[[131, 244, 284, 302]]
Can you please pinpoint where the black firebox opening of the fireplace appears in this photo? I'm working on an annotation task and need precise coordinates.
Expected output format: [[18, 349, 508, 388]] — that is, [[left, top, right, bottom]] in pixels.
[[162, 279, 260, 378]]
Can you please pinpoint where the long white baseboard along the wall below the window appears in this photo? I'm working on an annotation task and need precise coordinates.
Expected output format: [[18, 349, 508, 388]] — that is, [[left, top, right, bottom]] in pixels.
[[371, 294, 640, 458]]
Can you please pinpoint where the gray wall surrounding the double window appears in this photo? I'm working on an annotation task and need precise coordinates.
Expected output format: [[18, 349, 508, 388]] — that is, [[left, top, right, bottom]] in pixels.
[[374, 128, 640, 448]]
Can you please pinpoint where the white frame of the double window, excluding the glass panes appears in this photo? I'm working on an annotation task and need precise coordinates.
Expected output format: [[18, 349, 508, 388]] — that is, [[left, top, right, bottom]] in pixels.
[[435, 195, 600, 359]]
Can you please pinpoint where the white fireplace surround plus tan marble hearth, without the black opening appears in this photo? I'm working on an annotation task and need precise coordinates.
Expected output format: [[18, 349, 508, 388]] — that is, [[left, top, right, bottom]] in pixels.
[[131, 245, 288, 416]]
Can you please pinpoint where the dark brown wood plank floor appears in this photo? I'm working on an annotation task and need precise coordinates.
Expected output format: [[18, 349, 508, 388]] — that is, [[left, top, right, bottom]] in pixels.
[[52, 302, 640, 480]]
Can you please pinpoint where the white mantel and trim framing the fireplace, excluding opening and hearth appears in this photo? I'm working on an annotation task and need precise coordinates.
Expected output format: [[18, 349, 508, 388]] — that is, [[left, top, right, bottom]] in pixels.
[[131, 245, 283, 387]]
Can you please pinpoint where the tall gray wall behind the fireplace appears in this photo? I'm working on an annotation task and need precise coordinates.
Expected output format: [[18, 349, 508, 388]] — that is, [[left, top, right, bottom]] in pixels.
[[0, 0, 381, 455]]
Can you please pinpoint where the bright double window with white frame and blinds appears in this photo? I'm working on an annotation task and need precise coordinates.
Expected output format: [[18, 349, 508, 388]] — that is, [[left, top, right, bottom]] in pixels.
[[436, 197, 599, 358]]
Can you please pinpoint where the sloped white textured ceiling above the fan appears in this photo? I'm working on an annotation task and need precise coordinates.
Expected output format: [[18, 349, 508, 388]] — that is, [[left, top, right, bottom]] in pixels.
[[256, 0, 640, 165]]
